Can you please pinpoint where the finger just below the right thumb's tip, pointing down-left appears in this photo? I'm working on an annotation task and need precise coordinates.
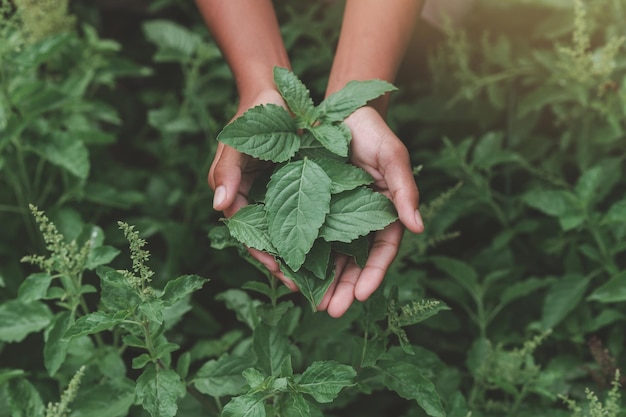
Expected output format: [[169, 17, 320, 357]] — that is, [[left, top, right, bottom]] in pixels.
[[354, 222, 404, 301]]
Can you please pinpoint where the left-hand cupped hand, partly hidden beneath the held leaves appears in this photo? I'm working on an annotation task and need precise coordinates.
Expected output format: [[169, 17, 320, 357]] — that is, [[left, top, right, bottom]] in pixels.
[[208, 90, 297, 291]]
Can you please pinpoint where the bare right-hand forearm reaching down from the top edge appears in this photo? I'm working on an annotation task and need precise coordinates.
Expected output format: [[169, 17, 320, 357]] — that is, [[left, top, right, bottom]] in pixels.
[[326, 0, 422, 113]]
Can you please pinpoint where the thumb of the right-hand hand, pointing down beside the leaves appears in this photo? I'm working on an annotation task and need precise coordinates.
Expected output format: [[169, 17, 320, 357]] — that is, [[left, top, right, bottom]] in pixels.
[[381, 144, 424, 233]]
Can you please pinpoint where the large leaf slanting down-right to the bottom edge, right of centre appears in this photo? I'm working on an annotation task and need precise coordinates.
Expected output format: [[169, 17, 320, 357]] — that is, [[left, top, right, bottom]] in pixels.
[[378, 360, 446, 417]]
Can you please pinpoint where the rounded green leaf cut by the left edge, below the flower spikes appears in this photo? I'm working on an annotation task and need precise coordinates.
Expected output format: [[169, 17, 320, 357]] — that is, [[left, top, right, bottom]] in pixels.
[[0, 300, 52, 342]]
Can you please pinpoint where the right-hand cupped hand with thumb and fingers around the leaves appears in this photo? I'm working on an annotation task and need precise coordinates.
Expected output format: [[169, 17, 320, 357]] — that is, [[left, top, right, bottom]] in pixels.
[[318, 107, 424, 317]]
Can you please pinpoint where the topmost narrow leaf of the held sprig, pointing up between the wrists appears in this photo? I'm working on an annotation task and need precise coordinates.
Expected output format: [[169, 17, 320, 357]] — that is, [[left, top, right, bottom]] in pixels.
[[274, 67, 317, 126]]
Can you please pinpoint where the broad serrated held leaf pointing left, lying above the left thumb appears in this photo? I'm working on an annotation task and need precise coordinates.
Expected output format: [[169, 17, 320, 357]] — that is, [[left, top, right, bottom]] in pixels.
[[217, 104, 300, 162]]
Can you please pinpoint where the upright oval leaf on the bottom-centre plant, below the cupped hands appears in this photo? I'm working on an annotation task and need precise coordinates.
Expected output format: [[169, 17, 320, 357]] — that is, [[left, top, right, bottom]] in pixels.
[[253, 323, 289, 376]]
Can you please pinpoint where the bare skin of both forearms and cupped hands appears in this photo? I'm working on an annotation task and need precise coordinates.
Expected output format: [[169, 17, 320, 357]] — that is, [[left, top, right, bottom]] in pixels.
[[196, 0, 424, 317]]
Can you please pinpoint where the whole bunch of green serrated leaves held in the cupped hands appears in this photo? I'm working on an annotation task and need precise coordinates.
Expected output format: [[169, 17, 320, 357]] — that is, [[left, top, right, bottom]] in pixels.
[[218, 67, 397, 308]]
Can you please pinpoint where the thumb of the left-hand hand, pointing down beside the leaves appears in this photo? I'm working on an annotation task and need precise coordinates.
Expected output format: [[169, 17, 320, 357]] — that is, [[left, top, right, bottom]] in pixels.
[[208, 145, 246, 211]]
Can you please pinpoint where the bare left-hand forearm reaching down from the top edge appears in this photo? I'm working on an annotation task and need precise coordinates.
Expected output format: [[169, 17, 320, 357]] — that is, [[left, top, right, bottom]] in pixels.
[[196, 0, 290, 102]]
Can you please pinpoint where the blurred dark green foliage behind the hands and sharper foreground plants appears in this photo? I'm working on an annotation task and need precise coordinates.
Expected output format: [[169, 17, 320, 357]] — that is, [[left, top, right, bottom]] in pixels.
[[0, 0, 626, 416]]
